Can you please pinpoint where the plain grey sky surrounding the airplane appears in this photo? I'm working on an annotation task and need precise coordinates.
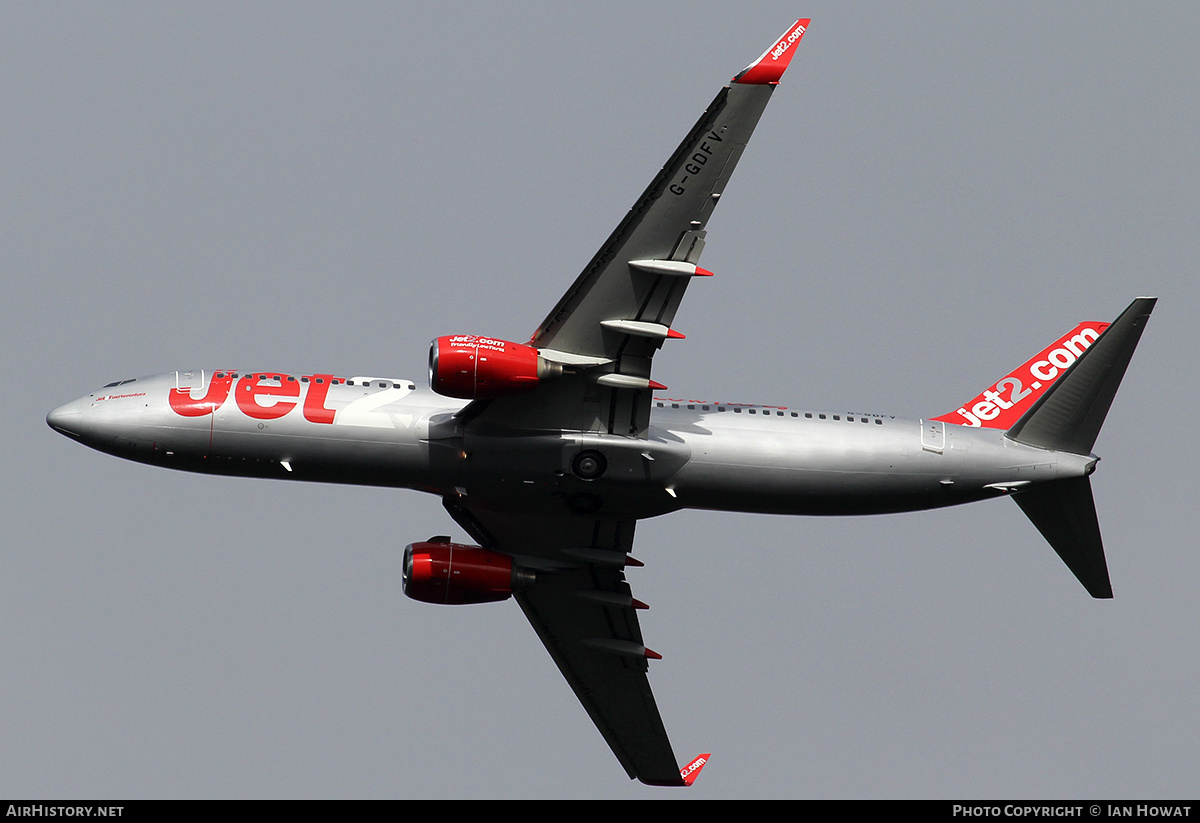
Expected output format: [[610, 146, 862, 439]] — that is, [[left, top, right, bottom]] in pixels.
[[0, 0, 1200, 799]]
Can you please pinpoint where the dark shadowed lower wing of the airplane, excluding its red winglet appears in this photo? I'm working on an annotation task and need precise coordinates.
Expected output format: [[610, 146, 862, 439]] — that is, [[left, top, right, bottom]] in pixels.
[[446, 499, 685, 786]]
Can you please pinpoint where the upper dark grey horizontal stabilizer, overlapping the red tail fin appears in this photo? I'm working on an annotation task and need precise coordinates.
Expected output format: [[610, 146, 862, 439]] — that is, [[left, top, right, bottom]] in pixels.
[[1008, 298, 1157, 453]]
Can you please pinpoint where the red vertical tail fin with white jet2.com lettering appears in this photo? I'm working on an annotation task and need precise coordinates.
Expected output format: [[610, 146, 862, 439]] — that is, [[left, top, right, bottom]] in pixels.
[[934, 323, 1109, 431]]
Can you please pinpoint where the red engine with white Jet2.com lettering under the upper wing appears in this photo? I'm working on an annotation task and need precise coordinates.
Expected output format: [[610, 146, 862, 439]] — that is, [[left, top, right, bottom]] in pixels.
[[430, 335, 563, 400]]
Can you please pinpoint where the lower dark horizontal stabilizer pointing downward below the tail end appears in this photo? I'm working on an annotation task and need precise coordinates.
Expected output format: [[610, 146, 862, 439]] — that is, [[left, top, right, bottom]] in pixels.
[[1013, 477, 1112, 597]]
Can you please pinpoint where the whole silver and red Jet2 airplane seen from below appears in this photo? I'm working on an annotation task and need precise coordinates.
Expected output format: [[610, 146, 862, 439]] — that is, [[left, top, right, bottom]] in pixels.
[[47, 19, 1156, 786]]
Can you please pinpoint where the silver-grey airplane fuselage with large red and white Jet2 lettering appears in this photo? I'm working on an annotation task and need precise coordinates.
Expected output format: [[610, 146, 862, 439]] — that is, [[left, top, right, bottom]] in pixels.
[[47, 370, 1096, 518]]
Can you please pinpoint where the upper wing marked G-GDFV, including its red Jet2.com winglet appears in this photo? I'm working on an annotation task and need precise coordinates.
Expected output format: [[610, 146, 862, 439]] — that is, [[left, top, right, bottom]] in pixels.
[[464, 19, 809, 437]]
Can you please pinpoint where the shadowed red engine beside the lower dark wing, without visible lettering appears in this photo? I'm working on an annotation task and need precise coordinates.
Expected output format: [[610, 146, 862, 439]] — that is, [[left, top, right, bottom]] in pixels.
[[403, 541, 535, 606]]
